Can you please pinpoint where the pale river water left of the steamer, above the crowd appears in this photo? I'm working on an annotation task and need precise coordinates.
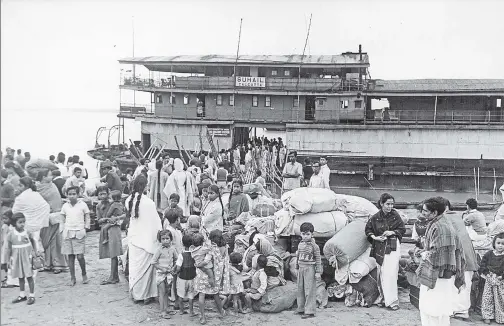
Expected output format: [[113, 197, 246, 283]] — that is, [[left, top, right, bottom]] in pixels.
[[0, 108, 141, 178]]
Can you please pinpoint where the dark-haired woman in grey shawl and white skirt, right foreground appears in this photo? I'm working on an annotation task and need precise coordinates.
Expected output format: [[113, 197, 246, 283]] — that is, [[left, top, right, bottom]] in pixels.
[[416, 198, 466, 326]]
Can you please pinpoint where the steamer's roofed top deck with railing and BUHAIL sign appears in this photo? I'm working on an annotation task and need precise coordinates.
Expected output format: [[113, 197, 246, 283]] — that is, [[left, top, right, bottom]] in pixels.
[[119, 53, 369, 95]]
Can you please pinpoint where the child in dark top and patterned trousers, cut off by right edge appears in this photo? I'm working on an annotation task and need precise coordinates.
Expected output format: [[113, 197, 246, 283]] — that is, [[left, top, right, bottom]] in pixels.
[[479, 233, 504, 324]]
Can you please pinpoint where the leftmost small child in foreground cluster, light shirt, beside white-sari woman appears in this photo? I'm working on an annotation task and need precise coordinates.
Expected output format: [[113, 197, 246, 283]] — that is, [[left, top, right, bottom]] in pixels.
[[151, 230, 178, 319]]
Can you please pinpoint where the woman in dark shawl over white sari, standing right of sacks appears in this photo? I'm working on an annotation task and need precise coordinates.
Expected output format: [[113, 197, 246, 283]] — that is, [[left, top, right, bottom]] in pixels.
[[365, 193, 406, 310]]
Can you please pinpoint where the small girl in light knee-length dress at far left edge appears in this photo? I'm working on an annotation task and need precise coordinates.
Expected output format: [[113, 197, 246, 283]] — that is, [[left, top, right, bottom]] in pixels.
[[2, 213, 37, 305]]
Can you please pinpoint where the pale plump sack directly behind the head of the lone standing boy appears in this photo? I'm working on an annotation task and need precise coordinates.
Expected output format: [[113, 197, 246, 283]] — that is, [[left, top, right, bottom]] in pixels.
[[293, 211, 347, 238]]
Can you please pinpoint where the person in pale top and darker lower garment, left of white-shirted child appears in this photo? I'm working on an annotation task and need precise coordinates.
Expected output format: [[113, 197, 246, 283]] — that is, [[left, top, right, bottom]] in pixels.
[[35, 170, 67, 274]]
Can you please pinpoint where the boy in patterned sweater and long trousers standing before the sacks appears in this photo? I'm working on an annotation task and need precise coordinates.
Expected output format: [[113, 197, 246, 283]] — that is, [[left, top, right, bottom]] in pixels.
[[296, 222, 322, 319]]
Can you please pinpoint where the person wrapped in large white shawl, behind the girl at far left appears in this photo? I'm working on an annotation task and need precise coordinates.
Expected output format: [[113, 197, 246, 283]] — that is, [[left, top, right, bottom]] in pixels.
[[12, 177, 50, 258]]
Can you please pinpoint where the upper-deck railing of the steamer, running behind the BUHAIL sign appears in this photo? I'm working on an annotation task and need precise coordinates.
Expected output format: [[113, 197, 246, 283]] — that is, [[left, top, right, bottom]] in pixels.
[[121, 76, 366, 93]]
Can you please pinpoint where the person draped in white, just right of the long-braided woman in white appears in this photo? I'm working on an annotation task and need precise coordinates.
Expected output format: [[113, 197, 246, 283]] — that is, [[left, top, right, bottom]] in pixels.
[[164, 158, 193, 217]]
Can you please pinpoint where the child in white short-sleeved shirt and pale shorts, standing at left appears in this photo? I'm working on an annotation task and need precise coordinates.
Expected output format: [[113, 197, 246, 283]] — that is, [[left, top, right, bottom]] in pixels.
[[61, 187, 91, 286]]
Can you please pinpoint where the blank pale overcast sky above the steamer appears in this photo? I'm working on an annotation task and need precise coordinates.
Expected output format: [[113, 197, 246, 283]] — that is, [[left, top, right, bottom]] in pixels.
[[1, 0, 504, 109]]
